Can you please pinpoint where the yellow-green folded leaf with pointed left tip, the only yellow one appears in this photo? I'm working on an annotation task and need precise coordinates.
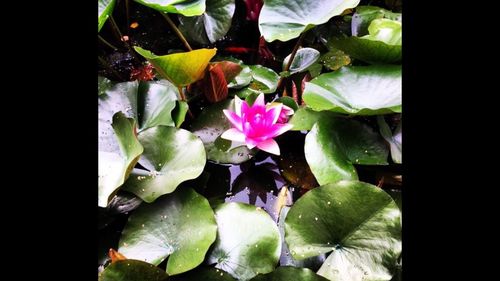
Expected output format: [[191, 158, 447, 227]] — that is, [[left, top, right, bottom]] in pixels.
[[134, 47, 217, 87]]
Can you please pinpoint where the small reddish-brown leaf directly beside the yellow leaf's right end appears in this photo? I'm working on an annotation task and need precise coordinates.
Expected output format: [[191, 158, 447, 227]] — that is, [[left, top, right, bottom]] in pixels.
[[201, 64, 228, 103]]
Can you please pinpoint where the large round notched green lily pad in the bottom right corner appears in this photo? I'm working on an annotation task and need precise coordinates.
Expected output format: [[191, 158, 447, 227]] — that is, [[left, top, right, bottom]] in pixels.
[[285, 181, 401, 281]]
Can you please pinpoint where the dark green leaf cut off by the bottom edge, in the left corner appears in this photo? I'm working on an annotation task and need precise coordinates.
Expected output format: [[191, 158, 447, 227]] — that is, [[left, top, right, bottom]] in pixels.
[[99, 259, 168, 281]]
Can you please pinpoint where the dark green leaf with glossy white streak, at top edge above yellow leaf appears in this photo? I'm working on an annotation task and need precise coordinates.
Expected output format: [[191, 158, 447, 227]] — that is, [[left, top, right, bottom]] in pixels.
[[179, 0, 235, 44]]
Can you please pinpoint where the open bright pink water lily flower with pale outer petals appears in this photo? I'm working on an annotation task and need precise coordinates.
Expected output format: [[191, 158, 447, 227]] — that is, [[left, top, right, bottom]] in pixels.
[[221, 94, 293, 155]]
